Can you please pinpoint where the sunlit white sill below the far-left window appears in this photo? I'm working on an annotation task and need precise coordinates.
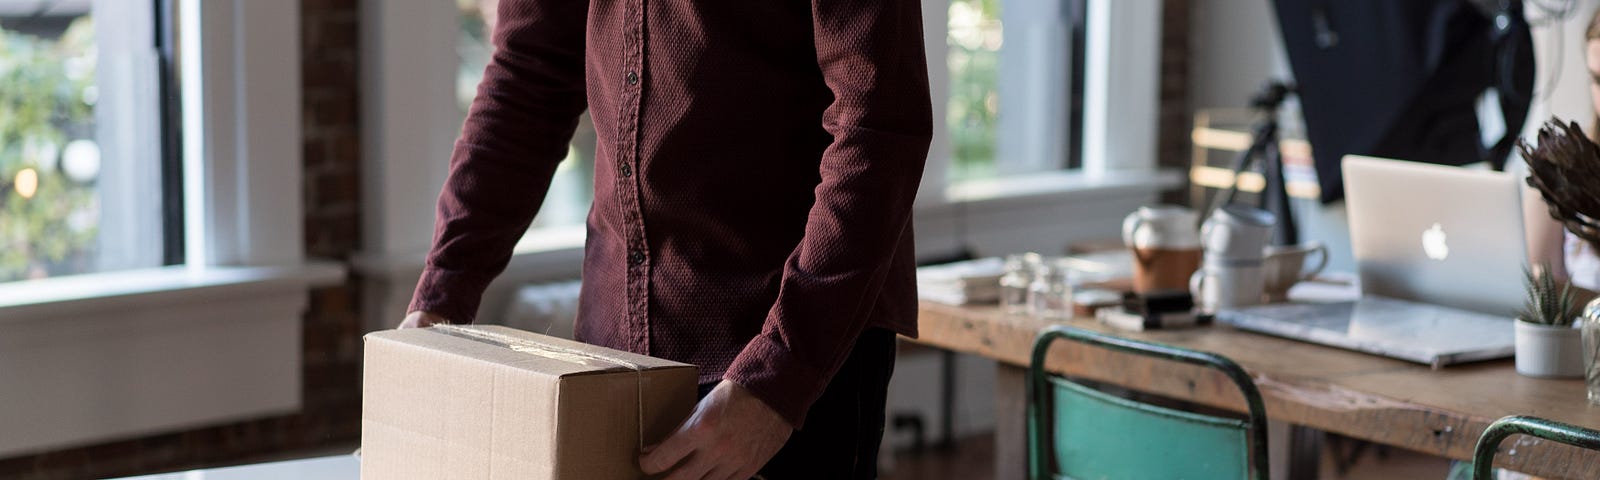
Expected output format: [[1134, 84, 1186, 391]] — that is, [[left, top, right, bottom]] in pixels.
[[0, 262, 344, 323]]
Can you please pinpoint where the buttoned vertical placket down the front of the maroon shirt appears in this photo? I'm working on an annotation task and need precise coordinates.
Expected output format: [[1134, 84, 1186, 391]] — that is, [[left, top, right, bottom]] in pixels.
[[616, 0, 650, 355]]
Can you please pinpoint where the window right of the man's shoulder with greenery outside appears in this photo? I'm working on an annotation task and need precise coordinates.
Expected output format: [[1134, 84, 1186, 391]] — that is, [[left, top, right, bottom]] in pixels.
[[930, 0, 1086, 182]]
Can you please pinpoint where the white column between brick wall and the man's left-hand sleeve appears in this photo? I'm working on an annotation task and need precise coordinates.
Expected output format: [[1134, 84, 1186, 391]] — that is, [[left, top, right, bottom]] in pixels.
[[355, 0, 464, 330]]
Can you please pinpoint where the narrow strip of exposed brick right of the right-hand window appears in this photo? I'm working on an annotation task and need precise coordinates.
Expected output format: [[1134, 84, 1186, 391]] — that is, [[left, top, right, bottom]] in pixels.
[[1157, 0, 1194, 203]]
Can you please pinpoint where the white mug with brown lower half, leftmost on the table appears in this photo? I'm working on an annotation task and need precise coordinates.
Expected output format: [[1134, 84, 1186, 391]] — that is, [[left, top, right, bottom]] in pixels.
[[1122, 205, 1200, 293]]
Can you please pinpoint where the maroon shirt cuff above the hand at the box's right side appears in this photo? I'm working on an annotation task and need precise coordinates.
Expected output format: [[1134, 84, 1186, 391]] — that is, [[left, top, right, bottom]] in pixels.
[[722, 334, 829, 430]]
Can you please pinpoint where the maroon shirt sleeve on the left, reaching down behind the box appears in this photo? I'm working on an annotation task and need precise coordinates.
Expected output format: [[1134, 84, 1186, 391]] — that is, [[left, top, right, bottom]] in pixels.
[[408, 0, 589, 323]]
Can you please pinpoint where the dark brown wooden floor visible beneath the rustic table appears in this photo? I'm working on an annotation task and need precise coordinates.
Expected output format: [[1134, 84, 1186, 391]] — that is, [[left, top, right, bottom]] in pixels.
[[880, 435, 1450, 480]]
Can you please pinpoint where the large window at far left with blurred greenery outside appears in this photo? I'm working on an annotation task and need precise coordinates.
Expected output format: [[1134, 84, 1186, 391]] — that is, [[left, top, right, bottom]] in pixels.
[[0, 0, 182, 282]]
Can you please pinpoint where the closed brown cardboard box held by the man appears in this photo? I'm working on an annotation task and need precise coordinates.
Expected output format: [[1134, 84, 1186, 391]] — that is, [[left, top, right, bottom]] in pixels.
[[362, 326, 696, 480]]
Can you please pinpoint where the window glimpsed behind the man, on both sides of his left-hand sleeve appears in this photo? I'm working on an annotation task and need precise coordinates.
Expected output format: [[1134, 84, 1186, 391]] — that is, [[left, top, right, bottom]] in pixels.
[[456, 0, 595, 229]]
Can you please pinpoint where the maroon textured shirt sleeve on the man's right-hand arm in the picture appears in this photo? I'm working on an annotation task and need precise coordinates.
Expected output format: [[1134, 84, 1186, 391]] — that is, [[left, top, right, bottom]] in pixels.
[[723, 0, 933, 427]]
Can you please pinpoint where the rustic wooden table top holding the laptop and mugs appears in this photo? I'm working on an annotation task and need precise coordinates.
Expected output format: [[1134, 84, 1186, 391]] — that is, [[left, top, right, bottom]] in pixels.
[[917, 301, 1600, 478]]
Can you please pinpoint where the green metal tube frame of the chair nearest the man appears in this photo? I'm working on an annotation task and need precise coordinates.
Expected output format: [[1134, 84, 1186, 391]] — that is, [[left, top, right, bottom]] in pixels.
[[1027, 325, 1269, 480]]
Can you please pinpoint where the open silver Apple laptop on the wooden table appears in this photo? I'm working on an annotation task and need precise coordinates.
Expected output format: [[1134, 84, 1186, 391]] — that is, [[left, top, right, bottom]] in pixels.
[[1216, 155, 1528, 368]]
